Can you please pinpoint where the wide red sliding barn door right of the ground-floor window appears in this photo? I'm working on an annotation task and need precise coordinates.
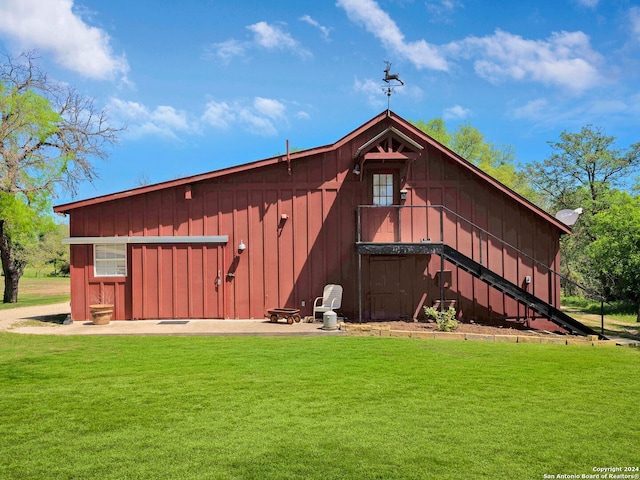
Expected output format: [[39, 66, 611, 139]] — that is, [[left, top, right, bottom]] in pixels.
[[131, 244, 223, 319]]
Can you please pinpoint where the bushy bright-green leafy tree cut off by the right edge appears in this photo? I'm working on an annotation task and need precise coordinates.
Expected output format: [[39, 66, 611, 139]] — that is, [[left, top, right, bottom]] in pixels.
[[587, 192, 640, 322]]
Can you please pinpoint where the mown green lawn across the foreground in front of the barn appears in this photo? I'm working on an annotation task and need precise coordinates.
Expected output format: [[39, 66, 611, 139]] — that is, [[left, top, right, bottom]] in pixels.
[[0, 334, 640, 480]]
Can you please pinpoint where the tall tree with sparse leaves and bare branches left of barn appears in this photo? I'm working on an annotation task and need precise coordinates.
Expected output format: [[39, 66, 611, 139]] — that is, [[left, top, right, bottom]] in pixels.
[[0, 53, 121, 303]]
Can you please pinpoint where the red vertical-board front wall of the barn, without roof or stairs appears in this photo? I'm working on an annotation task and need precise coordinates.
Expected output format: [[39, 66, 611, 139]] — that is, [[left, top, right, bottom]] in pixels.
[[70, 117, 560, 328]]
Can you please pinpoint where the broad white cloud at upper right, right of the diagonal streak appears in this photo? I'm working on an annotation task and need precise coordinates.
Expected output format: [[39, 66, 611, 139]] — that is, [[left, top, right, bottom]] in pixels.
[[448, 30, 602, 93]]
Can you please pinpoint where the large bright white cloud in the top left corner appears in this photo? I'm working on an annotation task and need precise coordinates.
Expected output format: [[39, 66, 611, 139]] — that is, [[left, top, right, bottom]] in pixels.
[[0, 0, 129, 81]]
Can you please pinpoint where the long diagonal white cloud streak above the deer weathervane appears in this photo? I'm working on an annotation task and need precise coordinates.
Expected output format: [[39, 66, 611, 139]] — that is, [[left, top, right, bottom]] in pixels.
[[337, 0, 448, 70]]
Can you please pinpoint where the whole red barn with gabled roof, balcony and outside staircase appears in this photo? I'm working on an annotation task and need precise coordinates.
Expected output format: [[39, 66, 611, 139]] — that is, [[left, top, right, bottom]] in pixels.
[[54, 110, 592, 334]]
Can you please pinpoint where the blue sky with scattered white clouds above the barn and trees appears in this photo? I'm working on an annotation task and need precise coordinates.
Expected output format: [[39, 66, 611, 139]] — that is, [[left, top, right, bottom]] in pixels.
[[0, 0, 640, 203]]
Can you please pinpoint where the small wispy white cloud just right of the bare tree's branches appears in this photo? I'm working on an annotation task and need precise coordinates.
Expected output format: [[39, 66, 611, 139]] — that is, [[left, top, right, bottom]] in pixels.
[[109, 98, 192, 140]]
